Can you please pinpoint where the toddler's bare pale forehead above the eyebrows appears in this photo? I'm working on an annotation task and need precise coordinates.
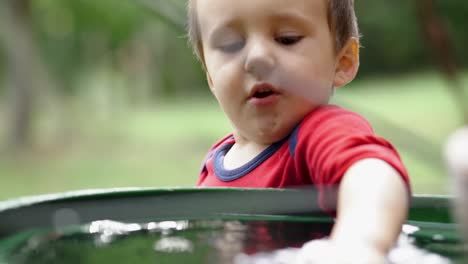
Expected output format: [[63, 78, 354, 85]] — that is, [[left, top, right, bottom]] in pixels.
[[195, 0, 328, 31]]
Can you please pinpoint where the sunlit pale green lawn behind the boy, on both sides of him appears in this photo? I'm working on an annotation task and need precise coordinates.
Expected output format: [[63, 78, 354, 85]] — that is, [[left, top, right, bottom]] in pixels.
[[0, 74, 466, 200]]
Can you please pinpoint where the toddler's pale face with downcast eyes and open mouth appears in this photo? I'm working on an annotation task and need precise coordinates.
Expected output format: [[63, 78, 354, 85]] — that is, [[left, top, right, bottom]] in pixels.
[[197, 0, 354, 144]]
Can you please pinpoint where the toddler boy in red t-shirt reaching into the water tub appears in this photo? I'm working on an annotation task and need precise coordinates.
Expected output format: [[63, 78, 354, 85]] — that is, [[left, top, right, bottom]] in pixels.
[[188, 0, 410, 264]]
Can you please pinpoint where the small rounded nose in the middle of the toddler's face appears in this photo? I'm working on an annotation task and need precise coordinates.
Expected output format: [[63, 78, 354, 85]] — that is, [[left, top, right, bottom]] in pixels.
[[244, 40, 276, 79]]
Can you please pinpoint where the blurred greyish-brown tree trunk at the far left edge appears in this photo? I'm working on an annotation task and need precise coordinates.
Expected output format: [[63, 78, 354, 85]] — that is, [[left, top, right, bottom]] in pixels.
[[0, 0, 37, 150]]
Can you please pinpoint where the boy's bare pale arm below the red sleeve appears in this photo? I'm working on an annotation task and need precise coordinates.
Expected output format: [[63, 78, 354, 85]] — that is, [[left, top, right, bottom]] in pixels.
[[331, 159, 409, 255]]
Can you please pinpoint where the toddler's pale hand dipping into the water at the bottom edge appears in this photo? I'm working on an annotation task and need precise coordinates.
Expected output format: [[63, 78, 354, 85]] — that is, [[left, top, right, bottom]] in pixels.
[[293, 239, 387, 264]]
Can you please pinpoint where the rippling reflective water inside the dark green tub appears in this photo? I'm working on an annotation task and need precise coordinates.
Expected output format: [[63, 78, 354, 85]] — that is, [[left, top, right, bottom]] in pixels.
[[5, 220, 466, 264]]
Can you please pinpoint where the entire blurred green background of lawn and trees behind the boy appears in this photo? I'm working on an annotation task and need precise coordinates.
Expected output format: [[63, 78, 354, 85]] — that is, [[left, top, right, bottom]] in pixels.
[[0, 0, 468, 200]]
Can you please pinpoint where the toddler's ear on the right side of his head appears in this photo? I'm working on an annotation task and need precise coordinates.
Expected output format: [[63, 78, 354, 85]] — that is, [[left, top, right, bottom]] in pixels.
[[333, 37, 359, 87]]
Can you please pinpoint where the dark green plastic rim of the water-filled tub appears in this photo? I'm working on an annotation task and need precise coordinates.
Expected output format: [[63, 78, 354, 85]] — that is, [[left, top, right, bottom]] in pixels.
[[0, 188, 459, 264]]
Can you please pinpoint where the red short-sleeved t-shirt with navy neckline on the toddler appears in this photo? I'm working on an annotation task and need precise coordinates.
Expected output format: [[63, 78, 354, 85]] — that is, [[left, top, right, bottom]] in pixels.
[[197, 105, 409, 209]]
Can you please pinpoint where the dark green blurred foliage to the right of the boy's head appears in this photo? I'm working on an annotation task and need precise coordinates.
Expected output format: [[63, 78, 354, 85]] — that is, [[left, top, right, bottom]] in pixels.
[[356, 0, 468, 75]]
